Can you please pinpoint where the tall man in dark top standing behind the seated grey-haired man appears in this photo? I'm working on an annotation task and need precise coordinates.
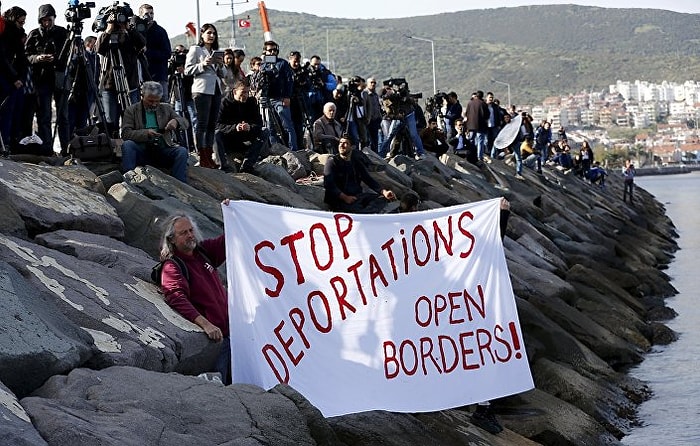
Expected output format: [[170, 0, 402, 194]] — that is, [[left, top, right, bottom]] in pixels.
[[139, 3, 172, 98]]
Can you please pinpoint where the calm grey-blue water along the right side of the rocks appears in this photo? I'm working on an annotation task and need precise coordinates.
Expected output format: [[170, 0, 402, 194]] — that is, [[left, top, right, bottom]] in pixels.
[[622, 172, 700, 446]]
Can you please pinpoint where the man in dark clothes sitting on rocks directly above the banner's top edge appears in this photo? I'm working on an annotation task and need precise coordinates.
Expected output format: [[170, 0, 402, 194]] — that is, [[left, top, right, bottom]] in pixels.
[[323, 134, 396, 214]]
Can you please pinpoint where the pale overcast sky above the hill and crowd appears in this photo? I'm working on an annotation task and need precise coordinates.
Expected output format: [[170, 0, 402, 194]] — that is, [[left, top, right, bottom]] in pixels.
[[2, 0, 700, 41]]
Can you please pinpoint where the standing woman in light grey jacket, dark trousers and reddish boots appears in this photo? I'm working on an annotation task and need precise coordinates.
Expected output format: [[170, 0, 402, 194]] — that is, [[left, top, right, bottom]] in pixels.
[[185, 23, 226, 169]]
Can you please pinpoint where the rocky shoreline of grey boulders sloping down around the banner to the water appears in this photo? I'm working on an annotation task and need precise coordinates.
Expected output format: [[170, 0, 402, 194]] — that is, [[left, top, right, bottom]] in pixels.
[[0, 147, 677, 446]]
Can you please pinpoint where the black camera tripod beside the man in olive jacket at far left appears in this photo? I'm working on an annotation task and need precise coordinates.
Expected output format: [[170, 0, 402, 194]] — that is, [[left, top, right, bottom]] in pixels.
[[52, 21, 107, 156]]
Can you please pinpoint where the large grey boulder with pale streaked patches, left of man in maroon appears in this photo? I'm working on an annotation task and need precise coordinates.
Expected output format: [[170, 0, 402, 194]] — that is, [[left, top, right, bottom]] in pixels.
[[0, 233, 220, 380]]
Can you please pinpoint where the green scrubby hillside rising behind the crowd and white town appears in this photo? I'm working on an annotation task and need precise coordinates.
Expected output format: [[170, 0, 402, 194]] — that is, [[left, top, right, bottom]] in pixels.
[[173, 5, 700, 104]]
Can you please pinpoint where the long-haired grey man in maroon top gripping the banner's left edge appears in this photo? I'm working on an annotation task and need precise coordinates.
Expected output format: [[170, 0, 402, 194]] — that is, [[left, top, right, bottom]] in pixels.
[[160, 213, 231, 385]]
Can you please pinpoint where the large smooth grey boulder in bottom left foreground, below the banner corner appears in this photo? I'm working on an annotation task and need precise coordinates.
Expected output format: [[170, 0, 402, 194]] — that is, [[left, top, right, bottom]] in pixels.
[[21, 367, 319, 446]]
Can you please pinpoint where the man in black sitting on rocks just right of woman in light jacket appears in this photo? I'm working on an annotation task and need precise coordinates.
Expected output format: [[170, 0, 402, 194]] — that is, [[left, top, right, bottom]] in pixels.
[[214, 81, 267, 173]]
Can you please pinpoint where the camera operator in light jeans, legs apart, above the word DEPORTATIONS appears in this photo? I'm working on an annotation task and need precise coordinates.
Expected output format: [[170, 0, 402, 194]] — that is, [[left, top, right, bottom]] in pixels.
[[379, 78, 425, 159]]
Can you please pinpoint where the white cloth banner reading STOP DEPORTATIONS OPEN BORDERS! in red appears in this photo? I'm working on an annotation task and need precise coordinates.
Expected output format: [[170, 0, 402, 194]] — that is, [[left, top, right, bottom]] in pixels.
[[222, 199, 533, 417]]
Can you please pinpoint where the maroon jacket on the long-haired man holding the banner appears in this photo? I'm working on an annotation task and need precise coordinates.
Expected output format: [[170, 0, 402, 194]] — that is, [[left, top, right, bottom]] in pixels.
[[161, 234, 229, 336]]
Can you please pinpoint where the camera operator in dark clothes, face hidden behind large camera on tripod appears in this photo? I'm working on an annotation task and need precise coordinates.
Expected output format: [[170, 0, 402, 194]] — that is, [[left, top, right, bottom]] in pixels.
[[93, 5, 146, 137]]
